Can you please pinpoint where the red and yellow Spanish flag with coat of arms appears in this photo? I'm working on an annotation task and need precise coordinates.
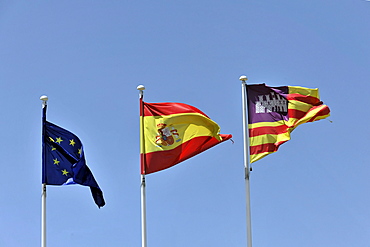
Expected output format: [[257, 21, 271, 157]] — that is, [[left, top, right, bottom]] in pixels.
[[140, 99, 232, 174]]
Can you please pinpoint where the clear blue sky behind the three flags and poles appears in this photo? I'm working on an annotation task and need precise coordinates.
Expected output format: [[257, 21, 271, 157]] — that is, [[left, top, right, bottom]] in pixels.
[[0, 0, 370, 247]]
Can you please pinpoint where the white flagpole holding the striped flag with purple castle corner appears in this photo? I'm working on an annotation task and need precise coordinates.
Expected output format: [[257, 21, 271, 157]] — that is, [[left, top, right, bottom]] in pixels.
[[239, 75, 252, 247]]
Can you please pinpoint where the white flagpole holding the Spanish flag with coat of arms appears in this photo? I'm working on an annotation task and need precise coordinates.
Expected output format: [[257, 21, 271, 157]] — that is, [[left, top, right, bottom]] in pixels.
[[137, 85, 147, 247]]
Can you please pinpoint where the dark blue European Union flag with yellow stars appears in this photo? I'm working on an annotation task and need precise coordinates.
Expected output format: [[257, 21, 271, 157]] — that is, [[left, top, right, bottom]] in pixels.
[[42, 118, 105, 208]]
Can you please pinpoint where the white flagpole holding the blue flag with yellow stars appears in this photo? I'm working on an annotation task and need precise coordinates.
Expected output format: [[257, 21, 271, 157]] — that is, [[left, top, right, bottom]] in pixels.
[[40, 95, 48, 247]]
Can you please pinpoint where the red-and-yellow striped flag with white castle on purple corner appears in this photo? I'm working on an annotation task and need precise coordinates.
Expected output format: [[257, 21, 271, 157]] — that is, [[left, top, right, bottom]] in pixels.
[[247, 84, 330, 163]]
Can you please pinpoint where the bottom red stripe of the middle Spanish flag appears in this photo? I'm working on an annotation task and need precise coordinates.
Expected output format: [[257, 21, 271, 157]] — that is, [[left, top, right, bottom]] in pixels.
[[141, 135, 232, 174]]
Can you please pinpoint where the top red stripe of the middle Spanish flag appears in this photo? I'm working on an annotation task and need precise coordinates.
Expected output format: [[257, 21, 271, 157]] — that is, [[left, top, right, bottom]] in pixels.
[[141, 102, 209, 118]]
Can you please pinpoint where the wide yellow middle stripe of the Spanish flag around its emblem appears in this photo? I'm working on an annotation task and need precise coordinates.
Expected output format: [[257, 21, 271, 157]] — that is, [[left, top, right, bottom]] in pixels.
[[140, 113, 221, 153]]
